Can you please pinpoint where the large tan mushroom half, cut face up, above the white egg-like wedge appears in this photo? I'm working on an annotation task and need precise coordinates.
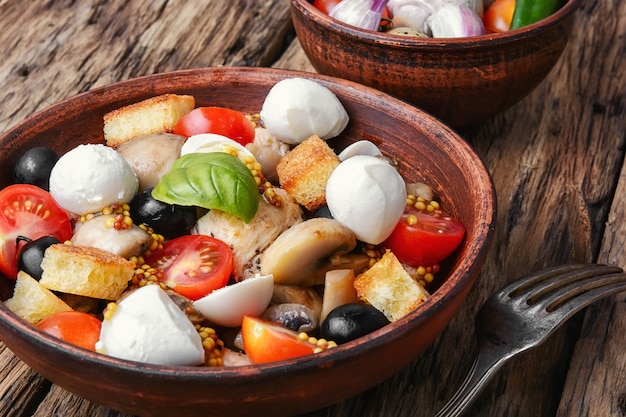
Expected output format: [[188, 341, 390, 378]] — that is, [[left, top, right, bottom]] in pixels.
[[260, 217, 356, 287]]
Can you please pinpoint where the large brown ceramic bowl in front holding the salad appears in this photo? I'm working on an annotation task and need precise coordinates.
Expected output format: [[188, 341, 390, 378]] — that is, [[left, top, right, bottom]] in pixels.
[[0, 68, 495, 417]]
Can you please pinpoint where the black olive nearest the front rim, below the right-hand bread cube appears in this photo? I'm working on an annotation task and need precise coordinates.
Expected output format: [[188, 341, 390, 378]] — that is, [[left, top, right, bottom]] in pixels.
[[320, 303, 389, 344]]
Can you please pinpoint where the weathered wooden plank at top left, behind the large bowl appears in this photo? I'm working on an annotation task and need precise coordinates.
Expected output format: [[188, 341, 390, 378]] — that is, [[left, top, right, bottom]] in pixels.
[[0, 0, 292, 131]]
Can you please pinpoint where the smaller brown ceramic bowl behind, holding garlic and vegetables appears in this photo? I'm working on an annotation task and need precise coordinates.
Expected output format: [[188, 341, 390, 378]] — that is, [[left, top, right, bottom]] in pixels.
[[291, 0, 582, 128]]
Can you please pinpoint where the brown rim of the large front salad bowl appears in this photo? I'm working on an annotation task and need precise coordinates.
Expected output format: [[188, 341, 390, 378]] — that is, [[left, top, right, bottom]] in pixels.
[[0, 67, 496, 381]]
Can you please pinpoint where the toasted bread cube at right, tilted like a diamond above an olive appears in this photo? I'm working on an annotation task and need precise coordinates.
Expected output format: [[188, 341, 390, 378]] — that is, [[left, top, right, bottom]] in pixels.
[[354, 251, 430, 322]]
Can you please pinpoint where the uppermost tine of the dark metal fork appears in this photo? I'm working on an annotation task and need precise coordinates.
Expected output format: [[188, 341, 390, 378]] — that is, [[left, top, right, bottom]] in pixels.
[[498, 263, 623, 300]]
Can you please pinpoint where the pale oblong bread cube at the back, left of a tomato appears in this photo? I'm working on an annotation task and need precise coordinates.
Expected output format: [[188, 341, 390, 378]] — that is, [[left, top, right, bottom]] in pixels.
[[104, 94, 196, 148]]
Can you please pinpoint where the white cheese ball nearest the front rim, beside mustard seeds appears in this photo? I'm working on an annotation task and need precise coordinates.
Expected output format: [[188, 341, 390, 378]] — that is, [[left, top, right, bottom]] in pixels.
[[96, 285, 204, 366]]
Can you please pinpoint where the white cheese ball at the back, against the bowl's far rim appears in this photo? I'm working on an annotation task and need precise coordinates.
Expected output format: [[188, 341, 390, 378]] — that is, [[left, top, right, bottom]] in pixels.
[[260, 78, 349, 145]]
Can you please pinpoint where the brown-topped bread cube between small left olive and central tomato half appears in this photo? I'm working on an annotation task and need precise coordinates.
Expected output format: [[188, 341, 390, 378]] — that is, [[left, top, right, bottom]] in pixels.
[[39, 243, 135, 300]]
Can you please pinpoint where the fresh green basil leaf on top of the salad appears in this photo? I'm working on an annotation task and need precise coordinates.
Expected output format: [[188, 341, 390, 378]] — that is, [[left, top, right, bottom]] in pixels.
[[152, 152, 259, 223]]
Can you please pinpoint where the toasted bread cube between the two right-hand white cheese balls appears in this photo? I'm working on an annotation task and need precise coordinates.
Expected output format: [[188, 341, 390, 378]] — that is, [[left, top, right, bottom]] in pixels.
[[276, 135, 340, 211]]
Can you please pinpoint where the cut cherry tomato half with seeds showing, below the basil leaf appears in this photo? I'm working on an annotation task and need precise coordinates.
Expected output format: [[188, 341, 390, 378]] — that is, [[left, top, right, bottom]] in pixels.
[[145, 235, 233, 301]]
